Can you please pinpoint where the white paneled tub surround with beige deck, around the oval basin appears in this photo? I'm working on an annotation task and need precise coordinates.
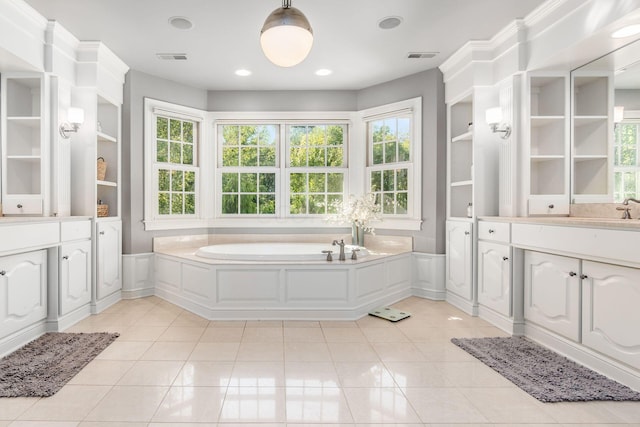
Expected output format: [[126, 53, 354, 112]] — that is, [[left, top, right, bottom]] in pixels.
[[154, 235, 412, 320]]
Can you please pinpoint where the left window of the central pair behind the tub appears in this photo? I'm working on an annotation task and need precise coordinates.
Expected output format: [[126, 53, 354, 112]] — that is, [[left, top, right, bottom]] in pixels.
[[218, 125, 279, 216]]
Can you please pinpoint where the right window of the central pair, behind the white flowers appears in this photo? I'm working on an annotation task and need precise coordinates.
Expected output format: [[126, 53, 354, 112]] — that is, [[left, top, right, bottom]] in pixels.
[[287, 125, 347, 215]]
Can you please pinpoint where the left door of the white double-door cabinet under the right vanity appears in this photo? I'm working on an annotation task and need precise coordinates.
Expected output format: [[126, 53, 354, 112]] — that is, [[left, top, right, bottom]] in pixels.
[[524, 251, 580, 342]]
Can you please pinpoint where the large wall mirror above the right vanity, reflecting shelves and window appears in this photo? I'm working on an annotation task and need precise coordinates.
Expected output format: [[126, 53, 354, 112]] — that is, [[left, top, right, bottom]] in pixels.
[[571, 40, 640, 203]]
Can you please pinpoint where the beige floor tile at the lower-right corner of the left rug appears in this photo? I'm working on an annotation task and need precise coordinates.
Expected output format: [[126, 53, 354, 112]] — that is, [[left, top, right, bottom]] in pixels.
[[19, 385, 111, 421]]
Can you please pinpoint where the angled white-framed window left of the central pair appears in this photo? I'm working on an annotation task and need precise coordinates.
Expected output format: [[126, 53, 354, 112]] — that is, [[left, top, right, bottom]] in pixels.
[[145, 99, 204, 229]]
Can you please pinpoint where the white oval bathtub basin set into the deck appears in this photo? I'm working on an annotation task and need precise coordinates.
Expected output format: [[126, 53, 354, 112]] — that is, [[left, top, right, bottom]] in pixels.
[[196, 242, 369, 261]]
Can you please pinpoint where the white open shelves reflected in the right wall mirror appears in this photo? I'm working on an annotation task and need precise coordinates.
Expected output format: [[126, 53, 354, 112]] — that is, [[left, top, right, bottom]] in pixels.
[[571, 71, 613, 202]]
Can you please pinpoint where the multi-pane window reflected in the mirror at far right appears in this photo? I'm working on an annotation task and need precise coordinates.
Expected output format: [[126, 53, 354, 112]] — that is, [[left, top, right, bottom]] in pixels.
[[613, 120, 640, 202]]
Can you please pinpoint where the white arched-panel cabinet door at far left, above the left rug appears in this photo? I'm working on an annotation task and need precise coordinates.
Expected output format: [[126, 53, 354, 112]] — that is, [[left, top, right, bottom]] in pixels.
[[0, 250, 47, 337]]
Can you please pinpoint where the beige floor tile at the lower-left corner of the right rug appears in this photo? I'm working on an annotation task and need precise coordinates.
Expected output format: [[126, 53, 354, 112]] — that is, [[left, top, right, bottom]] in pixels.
[[458, 387, 555, 424]]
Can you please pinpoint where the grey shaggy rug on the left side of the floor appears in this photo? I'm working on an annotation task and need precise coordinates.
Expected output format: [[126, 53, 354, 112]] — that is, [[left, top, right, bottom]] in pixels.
[[0, 332, 119, 397]]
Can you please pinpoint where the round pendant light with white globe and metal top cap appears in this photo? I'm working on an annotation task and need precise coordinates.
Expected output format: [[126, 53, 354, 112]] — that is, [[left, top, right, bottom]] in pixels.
[[260, 0, 313, 67]]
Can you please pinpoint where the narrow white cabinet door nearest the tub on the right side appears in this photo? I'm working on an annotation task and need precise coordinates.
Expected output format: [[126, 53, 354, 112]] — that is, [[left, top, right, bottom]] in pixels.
[[446, 221, 473, 301]]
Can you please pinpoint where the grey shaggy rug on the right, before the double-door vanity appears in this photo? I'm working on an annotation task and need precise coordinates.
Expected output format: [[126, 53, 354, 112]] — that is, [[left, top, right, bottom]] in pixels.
[[451, 337, 640, 402]]
